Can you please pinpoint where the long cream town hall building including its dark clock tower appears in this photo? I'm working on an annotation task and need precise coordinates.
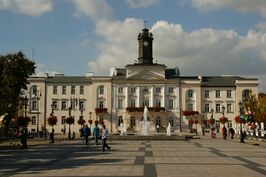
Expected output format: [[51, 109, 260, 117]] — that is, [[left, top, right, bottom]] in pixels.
[[25, 29, 258, 133]]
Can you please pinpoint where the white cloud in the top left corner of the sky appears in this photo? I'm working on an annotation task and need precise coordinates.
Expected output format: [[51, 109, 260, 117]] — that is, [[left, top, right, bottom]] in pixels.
[[0, 0, 53, 16]]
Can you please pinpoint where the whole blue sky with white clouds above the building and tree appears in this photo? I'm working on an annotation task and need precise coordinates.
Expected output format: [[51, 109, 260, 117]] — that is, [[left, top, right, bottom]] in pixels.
[[0, 0, 266, 93]]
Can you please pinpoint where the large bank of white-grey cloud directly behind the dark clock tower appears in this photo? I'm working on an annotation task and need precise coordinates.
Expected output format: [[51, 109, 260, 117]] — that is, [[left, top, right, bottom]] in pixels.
[[88, 18, 266, 90]]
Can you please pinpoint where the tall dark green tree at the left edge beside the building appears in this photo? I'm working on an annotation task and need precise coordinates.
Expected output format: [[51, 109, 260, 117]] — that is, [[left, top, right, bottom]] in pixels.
[[0, 52, 36, 133]]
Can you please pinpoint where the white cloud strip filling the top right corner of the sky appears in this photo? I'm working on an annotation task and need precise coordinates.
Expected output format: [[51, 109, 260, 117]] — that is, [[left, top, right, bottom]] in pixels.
[[191, 0, 266, 17]]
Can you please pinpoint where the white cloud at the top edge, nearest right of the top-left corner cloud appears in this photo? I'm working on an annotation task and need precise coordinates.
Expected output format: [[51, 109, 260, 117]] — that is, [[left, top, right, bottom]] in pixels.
[[73, 0, 113, 20]]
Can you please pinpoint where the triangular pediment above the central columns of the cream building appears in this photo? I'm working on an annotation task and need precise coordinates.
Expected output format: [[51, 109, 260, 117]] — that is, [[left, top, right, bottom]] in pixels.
[[127, 70, 165, 80]]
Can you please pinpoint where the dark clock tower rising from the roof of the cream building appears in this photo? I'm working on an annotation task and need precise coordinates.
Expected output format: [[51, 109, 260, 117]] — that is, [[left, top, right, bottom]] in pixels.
[[138, 28, 153, 64]]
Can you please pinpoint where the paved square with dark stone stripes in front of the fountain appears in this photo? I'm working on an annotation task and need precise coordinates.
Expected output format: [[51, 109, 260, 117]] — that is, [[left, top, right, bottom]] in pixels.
[[0, 138, 266, 177]]
